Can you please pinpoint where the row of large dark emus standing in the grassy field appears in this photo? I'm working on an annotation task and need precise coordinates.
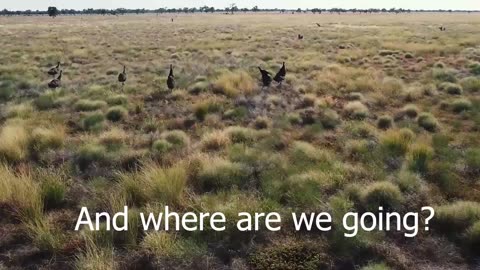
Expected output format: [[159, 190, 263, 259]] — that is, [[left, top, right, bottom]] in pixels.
[[47, 62, 287, 90]]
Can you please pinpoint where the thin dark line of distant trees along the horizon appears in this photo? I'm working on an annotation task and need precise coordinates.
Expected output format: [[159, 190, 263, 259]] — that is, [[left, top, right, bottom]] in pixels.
[[0, 4, 477, 17]]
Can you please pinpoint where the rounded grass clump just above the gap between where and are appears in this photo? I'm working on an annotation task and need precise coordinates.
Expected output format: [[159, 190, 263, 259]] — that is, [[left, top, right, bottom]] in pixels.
[[198, 158, 250, 191]]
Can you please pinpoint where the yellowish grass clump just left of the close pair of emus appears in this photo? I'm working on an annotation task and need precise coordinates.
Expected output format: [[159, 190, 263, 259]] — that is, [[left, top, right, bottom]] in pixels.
[[213, 71, 257, 97]]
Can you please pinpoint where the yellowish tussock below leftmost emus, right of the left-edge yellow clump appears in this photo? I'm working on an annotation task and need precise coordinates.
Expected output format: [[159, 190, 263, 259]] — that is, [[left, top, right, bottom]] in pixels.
[[30, 127, 66, 153]]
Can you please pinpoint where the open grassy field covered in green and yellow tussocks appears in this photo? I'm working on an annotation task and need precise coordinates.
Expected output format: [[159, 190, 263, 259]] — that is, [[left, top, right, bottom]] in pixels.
[[0, 13, 480, 270]]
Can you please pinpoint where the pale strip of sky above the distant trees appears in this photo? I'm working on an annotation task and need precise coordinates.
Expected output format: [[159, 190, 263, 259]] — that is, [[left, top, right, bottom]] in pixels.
[[0, 0, 480, 10]]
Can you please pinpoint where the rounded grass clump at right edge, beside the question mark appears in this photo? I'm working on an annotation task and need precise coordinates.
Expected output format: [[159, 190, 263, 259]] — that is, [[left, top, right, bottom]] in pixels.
[[434, 201, 480, 231]]
